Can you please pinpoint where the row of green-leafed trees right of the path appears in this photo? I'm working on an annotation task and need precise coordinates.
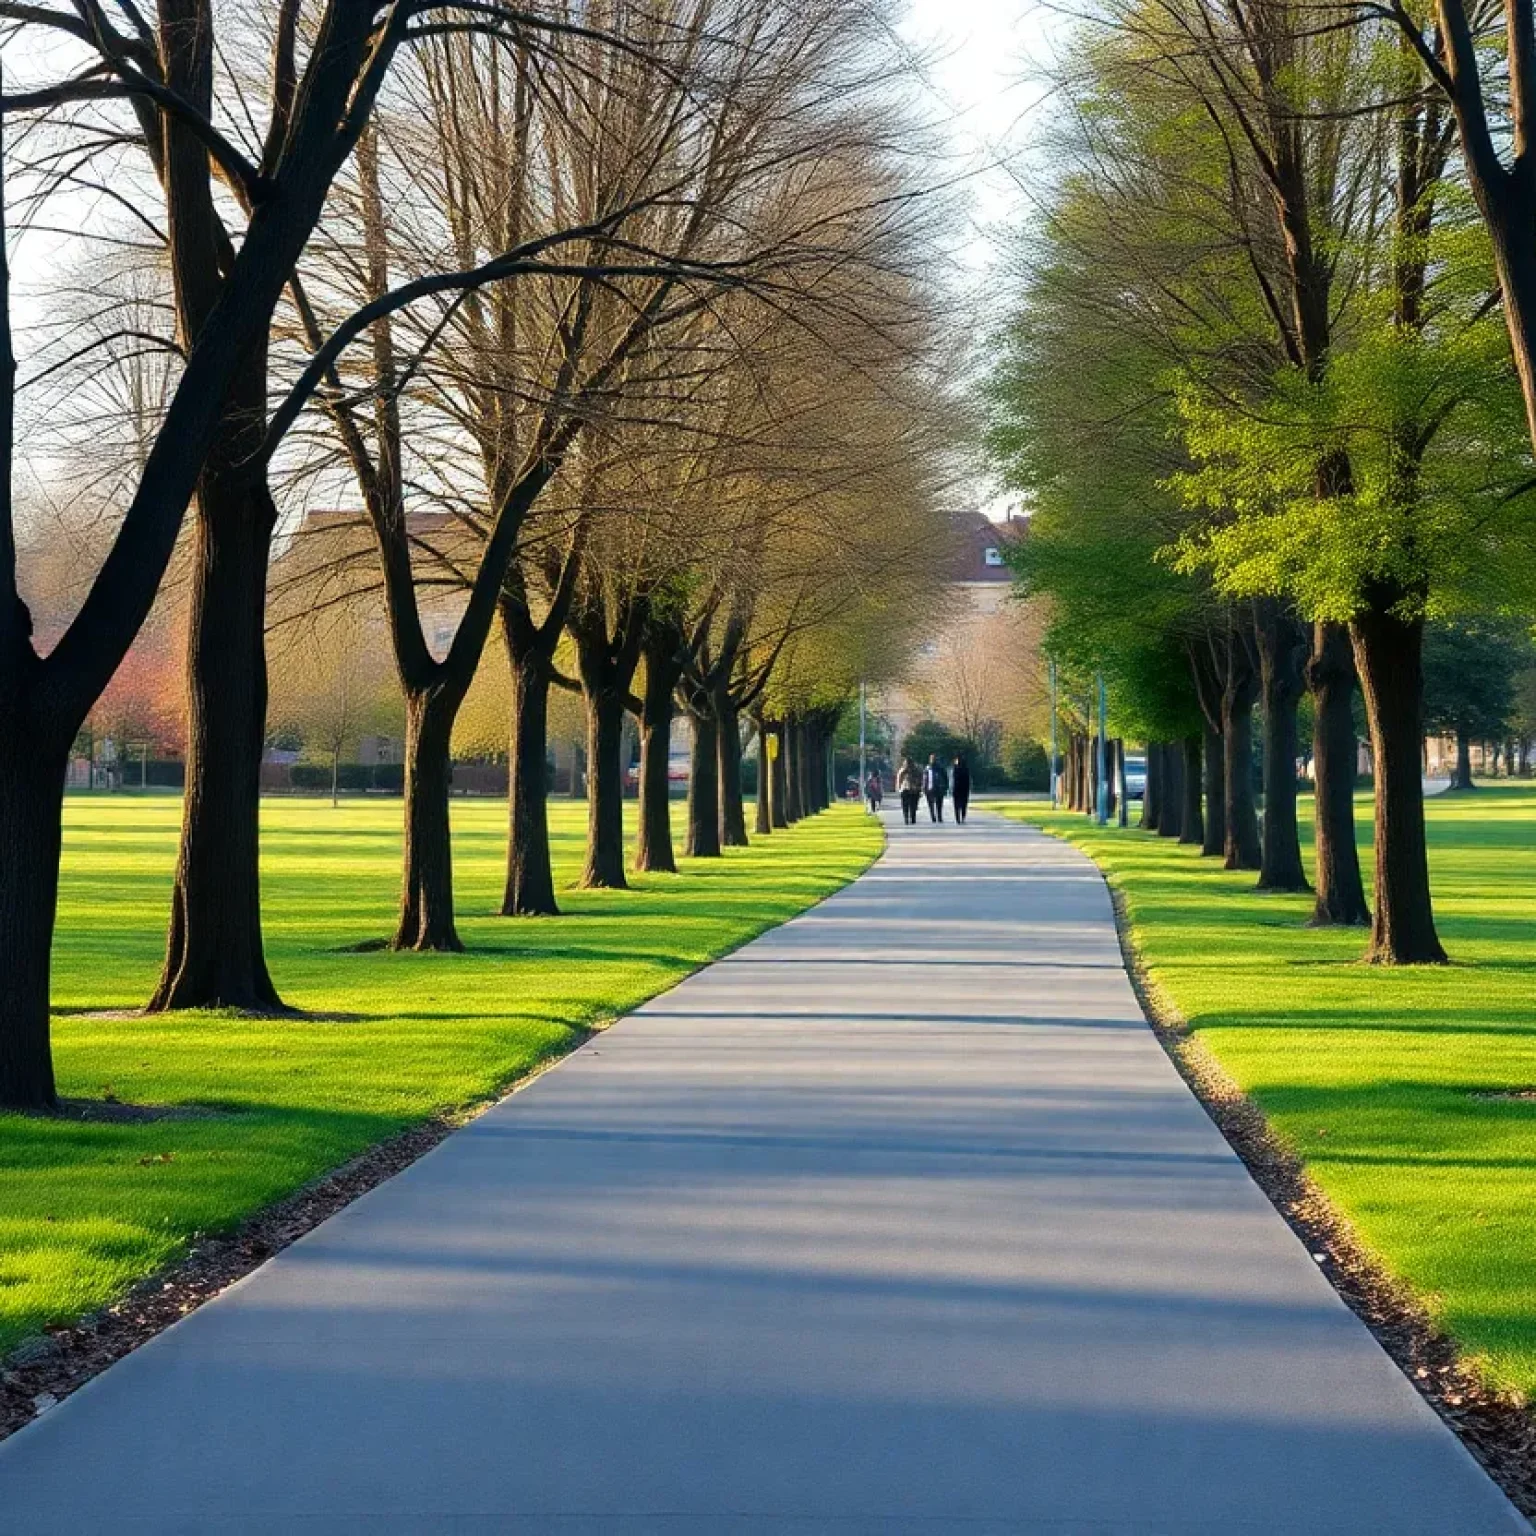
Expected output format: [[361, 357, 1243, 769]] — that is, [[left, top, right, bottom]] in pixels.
[[988, 0, 1536, 963]]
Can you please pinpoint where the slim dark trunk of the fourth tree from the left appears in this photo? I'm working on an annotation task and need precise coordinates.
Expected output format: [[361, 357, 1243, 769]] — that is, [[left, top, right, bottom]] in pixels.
[[501, 622, 561, 917]]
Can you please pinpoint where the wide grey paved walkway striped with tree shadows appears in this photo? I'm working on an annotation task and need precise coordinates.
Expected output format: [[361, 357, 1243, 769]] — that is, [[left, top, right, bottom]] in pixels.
[[0, 820, 1530, 1536]]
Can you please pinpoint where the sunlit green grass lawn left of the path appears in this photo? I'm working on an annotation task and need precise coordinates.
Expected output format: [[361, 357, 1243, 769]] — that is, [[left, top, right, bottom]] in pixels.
[[0, 796, 882, 1353]]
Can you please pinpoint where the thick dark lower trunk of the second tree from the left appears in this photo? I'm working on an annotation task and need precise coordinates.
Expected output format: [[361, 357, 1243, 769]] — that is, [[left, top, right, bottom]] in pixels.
[[147, 491, 283, 1012]]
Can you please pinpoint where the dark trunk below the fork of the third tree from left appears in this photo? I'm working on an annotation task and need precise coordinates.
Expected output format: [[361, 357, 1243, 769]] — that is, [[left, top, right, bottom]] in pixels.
[[390, 693, 464, 952]]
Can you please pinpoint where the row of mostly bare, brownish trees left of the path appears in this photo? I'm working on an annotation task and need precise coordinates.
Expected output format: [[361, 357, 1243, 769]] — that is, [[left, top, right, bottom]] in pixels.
[[0, 0, 943, 1107]]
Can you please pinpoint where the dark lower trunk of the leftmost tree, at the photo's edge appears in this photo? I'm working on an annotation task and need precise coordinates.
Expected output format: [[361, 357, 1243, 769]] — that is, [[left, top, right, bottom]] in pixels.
[[0, 737, 68, 1109]]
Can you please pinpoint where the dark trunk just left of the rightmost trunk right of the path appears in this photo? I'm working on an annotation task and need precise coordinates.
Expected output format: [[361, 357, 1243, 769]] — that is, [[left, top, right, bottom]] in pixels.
[[1307, 624, 1370, 928]]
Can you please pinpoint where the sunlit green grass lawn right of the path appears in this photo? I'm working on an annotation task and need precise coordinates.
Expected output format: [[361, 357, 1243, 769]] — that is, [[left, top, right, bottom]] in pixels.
[[998, 788, 1536, 1395]]
